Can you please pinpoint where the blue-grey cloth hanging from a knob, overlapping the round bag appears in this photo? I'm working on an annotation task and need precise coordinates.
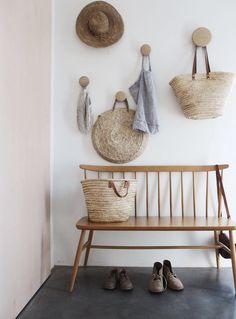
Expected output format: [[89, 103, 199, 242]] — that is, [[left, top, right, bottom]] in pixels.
[[129, 56, 159, 134]]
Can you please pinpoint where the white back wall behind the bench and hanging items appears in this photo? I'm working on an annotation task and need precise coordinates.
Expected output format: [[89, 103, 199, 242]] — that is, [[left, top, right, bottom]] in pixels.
[[53, 0, 236, 266]]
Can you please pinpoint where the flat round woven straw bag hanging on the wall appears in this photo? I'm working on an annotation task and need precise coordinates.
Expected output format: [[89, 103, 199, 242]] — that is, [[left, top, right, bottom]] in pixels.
[[92, 108, 148, 163]]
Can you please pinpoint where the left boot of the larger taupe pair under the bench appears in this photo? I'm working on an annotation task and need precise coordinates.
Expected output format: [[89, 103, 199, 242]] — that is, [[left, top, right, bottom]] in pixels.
[[148, 262, 167, 293]]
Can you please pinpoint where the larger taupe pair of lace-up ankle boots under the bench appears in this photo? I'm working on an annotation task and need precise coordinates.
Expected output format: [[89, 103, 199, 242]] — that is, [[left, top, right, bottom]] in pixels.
[[148, 260, 184, 293]]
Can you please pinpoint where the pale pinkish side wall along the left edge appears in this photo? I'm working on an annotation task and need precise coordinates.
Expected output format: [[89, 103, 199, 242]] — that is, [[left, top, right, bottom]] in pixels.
[[0, 0, 51, 319]]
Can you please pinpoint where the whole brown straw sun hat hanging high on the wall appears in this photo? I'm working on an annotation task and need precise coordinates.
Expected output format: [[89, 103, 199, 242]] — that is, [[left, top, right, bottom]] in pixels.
[[76, 1, 124, 48]]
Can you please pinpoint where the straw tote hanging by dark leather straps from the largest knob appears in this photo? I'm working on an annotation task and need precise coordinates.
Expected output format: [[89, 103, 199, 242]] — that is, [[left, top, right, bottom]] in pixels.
[[170, 46, 234, 120]]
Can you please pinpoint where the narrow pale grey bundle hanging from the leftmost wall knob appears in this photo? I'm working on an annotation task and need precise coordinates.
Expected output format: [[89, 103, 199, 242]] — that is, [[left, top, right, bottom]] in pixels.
[[77, 88, 93, 134]]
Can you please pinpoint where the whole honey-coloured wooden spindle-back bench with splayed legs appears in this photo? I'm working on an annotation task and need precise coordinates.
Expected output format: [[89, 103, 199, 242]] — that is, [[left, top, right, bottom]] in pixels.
[[69, 164, 236, 292]]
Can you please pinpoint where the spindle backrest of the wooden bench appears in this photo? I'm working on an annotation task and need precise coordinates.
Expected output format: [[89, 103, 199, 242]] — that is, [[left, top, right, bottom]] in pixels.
[[80, 164, 229, 217]]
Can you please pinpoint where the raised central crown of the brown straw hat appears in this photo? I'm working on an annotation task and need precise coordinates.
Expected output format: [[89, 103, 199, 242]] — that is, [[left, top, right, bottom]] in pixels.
[[88, 11, 109, 35]]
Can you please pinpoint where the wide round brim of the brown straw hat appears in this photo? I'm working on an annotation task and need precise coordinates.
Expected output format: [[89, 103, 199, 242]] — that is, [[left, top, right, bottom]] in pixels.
[[76, 1, 124, 48]]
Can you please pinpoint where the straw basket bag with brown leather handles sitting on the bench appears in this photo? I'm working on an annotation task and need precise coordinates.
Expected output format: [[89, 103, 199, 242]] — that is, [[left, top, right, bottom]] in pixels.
[[81, 179, 137, 223]]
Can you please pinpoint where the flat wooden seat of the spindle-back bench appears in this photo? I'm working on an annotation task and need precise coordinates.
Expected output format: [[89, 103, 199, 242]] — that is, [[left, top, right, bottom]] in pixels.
[[76, 216, 236, 231]]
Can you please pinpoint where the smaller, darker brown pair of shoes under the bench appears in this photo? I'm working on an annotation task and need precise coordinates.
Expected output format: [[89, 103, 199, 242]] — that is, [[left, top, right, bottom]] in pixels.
[[103, 268, 134, 291]]
